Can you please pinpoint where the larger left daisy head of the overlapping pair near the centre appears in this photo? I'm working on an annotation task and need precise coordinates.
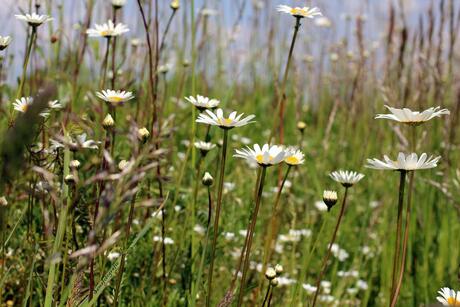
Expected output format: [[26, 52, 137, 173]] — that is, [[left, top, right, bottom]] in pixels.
[[233, 144, 286, 166]]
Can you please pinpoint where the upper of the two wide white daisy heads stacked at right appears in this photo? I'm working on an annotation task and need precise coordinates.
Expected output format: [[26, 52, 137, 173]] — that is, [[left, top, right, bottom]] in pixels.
[[375, 105, 450, 126]]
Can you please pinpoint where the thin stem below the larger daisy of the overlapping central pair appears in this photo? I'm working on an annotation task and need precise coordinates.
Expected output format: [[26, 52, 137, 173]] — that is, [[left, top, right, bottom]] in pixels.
[[238, 167, 267, 306]]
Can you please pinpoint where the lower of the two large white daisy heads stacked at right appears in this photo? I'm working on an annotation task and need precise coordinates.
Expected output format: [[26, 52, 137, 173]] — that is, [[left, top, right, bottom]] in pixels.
[[366, 152, 441, 171]]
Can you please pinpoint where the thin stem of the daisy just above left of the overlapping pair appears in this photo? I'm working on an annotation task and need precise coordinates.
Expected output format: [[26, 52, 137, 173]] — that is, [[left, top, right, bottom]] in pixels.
[[206, 129, 228, 307]]
